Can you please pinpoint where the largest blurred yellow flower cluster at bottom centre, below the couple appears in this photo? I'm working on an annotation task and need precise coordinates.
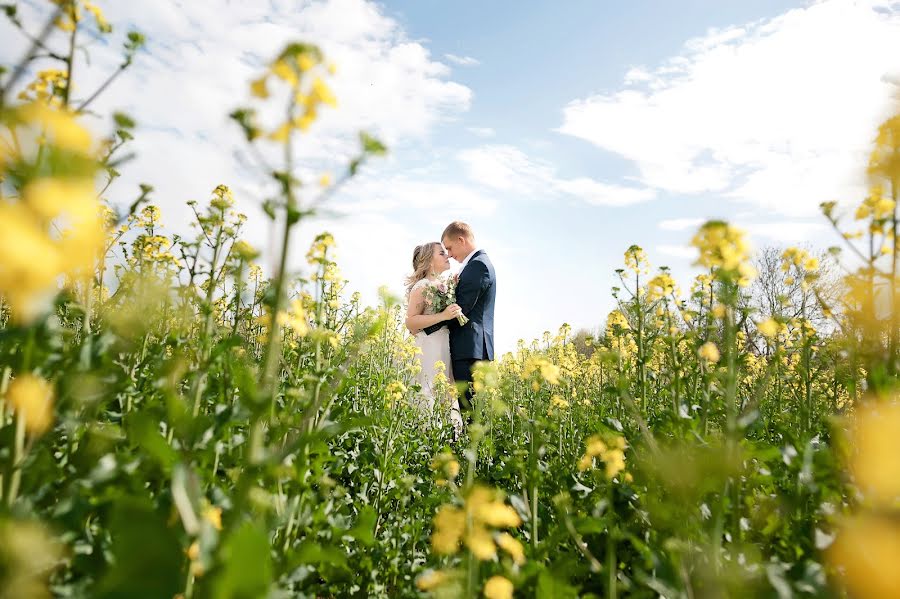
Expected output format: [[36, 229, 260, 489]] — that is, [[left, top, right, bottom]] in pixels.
[[431, 486, 524, 561]]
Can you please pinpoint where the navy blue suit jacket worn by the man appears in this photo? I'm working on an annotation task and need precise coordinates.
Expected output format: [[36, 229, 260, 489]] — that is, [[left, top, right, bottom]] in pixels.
[[425, 250, 497, 360]]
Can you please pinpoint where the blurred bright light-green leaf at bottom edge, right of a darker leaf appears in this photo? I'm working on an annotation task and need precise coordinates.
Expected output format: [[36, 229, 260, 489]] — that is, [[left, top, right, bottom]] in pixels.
[[213, 522, 272, 599]]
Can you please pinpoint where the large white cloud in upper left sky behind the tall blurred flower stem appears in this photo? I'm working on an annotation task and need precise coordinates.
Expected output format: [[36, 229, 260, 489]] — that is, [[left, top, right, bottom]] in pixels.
[[0, 0, 472, 211]]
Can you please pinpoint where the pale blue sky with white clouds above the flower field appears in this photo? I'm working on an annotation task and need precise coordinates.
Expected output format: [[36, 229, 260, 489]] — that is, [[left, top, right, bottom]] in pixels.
[[0, 0, 900, 351]]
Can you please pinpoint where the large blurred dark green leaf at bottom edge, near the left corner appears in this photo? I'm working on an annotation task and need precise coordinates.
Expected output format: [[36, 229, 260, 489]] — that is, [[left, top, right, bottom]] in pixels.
[[96, 497, 184, 599]]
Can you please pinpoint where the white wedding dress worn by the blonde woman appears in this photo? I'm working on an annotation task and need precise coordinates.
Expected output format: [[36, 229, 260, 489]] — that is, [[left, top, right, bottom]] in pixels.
[[412, 279, 462, 432]]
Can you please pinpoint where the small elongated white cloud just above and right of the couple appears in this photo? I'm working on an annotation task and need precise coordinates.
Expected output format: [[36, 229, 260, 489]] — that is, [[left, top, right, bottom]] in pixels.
[[458, 145, 656, 206]]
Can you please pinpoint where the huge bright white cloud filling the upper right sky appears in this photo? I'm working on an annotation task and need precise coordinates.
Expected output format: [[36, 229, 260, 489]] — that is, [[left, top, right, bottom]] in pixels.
[[560, 0, 900, 216]]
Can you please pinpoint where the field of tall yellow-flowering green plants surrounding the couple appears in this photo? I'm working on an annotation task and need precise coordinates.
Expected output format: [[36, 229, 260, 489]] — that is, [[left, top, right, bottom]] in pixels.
[[0, 0, 900, 599]]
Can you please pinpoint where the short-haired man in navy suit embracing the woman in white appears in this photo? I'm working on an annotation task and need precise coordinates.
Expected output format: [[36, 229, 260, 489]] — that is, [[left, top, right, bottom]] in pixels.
[[425, 221, 497, 420]]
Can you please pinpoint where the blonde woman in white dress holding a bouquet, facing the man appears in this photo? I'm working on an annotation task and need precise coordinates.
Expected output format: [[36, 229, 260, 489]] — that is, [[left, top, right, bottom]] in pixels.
[[406, 242, 462, 432]]
